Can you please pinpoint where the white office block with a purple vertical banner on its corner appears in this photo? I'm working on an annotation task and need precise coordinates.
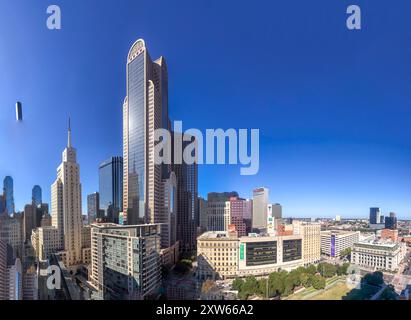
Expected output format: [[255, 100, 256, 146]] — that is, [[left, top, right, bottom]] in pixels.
[[321, 230, 360, 258]]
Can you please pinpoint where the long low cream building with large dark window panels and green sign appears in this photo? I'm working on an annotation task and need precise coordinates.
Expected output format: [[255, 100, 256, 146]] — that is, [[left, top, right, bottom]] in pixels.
[[197, 231, 304, 279]]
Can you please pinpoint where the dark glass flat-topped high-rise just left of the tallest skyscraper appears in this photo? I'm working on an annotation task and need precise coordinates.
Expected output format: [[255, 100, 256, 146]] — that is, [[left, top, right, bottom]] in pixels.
[[99, 157, 123, 223]]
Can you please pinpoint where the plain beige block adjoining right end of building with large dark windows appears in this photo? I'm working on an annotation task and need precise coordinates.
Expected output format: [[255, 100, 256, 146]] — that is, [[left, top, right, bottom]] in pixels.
[[292, 220, 321, 266]]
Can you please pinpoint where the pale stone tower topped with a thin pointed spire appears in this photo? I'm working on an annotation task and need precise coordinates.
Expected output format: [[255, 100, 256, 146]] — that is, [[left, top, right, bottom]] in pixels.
[[51, 120, 83, 267]]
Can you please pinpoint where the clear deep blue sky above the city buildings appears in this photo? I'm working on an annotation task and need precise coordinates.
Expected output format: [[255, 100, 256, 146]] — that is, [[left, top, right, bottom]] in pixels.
[[0, 0, 411, 218]]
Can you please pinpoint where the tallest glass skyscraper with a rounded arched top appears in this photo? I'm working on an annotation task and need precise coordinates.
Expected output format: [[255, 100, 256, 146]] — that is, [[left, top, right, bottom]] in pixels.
[[123, 39, 169, 225]]
